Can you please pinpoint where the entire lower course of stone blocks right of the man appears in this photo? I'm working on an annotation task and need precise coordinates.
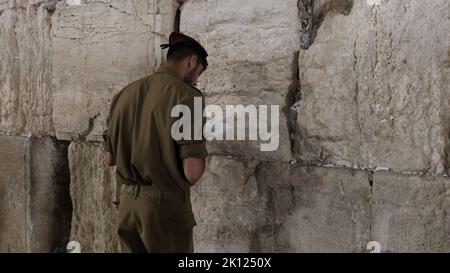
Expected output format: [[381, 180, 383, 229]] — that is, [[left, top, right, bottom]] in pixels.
[[196, 156, 450, 252]]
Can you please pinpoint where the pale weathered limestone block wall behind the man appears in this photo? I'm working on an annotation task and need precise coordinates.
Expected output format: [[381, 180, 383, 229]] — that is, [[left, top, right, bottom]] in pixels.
[[0, 0, 450, 252]]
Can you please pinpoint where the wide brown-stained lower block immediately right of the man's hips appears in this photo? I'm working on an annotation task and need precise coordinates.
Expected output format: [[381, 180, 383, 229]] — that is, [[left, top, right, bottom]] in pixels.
[[192, 156, 371, 252]]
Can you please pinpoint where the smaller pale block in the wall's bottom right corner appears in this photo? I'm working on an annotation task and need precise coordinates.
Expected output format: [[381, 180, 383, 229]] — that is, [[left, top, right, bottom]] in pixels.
[[371, 172, 450, 252]]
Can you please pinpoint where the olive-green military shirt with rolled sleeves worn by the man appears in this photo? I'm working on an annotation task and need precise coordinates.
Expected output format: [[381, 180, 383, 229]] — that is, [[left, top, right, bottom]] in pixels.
[[103, 66, 208, 190]]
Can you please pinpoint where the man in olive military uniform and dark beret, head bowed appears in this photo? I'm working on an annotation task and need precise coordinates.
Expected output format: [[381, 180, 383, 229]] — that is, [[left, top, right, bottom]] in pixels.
[[103, 32, 208, 252]]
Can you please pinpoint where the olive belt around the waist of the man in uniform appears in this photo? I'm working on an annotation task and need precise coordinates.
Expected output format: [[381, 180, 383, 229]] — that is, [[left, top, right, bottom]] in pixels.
[[122, 184, 190, 202]]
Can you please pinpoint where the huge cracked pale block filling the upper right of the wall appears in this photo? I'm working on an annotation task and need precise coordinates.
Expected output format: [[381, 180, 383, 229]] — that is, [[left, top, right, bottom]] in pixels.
[[295, 0, 450, 174]]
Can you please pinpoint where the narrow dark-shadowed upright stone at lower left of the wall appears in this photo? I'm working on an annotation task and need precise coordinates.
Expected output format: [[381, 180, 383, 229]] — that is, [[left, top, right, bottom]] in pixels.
[[30, 136, 73, 252]]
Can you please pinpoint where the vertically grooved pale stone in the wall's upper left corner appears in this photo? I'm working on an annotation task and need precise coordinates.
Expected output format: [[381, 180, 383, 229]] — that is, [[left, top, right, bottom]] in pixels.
[[0, 1, 53, 135]]
